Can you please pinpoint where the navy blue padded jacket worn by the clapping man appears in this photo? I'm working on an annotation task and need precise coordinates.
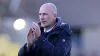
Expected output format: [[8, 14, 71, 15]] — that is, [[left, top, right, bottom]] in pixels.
[[18, 18, 71, 56]]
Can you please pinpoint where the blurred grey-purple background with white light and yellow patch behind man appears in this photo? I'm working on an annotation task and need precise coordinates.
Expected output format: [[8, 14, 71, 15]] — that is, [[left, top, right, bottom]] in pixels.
[[0, 0, 100, 56]]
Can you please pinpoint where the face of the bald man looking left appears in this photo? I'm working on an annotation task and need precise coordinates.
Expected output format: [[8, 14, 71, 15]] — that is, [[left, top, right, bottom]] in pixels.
[[39, 7, 56, 28]]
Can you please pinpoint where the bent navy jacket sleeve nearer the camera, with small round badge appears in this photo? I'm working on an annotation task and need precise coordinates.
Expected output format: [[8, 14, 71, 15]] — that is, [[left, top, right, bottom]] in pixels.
[[36, 32, 71, 56]]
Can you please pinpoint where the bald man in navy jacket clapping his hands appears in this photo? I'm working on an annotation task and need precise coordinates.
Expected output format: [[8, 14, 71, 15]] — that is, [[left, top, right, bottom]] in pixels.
[[18, 3, 71, 56]]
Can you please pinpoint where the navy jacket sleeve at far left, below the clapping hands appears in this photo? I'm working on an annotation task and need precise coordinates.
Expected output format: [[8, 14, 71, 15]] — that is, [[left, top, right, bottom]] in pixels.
[[18, 44, 35, 56]]
